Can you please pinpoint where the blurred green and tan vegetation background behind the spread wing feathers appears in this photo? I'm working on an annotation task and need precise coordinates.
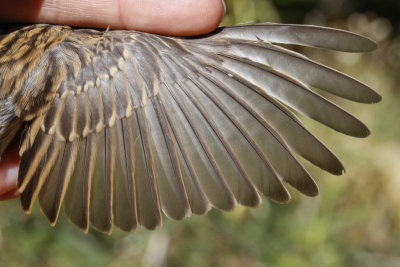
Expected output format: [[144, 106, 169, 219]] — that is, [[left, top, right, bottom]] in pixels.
[[0, 0, 400, 267]]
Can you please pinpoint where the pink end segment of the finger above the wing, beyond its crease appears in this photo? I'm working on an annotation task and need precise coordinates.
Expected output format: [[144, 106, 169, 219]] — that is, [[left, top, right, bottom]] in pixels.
[[120, 0, 224, 36]]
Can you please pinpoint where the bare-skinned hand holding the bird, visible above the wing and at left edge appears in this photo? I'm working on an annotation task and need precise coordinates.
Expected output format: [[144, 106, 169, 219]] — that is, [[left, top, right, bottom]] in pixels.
[[0, 0, 224, 200]]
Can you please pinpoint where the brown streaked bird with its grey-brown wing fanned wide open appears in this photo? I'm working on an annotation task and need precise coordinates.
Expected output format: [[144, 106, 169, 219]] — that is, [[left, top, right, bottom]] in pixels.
[[0, 23, 381, 234]]
